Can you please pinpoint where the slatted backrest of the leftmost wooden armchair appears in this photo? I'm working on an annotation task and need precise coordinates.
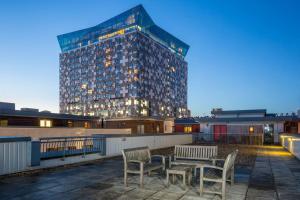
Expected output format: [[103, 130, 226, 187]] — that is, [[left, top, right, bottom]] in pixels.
[[122, 147, 151, 164]]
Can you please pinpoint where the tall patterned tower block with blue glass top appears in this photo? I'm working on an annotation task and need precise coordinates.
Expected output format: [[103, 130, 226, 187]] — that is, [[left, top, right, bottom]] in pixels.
[[58, 5, 189, 124]]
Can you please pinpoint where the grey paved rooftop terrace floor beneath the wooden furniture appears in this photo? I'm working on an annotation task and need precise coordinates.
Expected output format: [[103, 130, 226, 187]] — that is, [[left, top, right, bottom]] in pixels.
[[0, 146, 300, 200]]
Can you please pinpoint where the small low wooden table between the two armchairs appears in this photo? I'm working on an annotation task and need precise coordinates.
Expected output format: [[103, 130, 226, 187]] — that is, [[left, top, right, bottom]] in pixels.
[[167, 165, 195, 186]]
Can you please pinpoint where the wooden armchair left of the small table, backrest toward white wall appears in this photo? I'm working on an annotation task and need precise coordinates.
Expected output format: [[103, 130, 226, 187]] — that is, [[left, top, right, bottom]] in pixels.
[[122, 147, 165, 187]]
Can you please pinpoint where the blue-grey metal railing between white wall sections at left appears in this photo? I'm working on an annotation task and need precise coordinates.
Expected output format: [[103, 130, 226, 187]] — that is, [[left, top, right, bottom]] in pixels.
[[40, 136, 106, 159]]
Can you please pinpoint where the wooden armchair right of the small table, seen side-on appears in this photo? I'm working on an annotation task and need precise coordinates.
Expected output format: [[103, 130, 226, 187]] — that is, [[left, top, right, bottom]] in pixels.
[[200, 150, 238, 200]]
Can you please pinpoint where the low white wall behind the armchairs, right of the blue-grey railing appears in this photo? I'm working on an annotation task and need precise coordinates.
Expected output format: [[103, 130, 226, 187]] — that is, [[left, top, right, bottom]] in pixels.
[[106, 134, 193, 156]]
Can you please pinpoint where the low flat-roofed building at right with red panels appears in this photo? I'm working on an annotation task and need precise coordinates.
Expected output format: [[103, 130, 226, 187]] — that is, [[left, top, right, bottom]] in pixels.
[[195, 109, 300, 143]]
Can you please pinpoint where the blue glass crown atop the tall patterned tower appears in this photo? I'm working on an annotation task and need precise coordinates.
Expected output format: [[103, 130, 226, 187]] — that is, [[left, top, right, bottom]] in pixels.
[[57, 5, 189, 57]]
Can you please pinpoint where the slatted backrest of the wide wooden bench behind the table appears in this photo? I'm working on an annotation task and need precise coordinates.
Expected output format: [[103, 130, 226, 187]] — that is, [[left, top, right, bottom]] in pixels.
[[174, 145, 218, 160]]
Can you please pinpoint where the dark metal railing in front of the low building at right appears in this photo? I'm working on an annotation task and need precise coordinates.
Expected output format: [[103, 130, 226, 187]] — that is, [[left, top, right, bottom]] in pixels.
[[193, 133, 264, 145]]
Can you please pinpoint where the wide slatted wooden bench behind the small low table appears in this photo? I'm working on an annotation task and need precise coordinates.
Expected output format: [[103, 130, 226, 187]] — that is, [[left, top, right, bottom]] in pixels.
[[170, 145, 218, 168]]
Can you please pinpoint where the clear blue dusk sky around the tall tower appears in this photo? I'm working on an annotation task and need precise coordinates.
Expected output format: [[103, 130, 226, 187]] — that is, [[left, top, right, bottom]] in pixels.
[[0, 0, 300, 115]]
